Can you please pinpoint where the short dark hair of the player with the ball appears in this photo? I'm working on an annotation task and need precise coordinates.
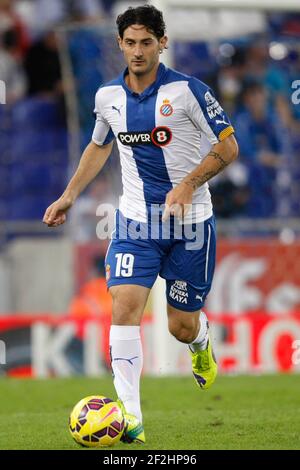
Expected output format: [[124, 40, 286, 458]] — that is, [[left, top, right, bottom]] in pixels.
[[117, 5, 166, 39]]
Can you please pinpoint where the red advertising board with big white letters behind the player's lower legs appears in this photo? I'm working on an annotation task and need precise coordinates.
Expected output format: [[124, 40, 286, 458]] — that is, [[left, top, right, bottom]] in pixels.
[[0, 312, 300, 377]]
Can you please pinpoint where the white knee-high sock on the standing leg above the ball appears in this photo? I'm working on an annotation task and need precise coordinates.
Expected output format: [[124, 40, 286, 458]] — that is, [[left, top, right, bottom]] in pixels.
[[109, 325, 143, 421]]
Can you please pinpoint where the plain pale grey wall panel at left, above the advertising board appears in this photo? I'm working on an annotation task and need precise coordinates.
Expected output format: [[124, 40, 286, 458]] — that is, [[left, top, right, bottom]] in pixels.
[[0, 241, 74, 315]]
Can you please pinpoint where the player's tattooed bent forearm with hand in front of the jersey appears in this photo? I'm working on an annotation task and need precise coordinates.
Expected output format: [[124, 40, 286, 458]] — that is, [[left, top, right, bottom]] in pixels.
[[163, 134, 238, 220]]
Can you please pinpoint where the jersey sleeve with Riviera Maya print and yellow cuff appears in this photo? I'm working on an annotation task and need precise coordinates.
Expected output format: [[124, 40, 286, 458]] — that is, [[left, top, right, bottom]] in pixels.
[[186, 77, 234, 144]]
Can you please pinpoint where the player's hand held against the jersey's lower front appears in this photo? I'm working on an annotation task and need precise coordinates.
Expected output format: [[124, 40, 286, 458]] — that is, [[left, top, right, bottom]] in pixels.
[[162, 181, 194, 222]]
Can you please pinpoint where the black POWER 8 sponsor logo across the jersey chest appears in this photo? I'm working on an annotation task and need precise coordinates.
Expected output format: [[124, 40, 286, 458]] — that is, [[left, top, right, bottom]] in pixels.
[[118, 126, 172, 147]]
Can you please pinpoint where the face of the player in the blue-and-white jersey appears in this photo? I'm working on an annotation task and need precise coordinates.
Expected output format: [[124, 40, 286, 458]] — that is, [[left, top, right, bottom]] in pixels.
[[118, 24, 167, 75]]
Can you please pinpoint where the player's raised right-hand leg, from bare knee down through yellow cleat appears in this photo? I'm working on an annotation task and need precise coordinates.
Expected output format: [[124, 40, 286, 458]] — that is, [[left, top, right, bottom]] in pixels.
[[168, 304, 218, 389]]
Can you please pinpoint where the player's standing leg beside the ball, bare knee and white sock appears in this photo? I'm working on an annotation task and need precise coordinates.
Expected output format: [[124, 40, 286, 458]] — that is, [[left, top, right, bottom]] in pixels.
[[110, 284, 150, 422]]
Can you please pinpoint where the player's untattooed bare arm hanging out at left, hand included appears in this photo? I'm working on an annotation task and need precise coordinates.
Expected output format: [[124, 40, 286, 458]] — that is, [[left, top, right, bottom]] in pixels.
[[43, 141, 113, 227]]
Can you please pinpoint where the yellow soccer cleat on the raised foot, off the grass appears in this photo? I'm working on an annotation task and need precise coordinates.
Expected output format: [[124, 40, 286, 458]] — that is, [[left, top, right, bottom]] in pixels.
[[190, 340, 218, 390]]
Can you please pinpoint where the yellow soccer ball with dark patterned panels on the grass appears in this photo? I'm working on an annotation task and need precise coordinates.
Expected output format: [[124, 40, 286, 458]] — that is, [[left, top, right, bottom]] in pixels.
[[69, 395, 125, 447]]
